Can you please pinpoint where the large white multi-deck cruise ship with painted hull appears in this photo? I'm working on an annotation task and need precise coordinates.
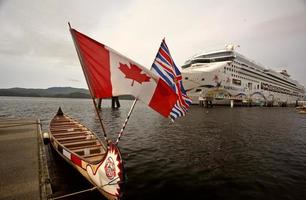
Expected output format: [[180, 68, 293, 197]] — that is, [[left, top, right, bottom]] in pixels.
[[182, 45, 305, 106]]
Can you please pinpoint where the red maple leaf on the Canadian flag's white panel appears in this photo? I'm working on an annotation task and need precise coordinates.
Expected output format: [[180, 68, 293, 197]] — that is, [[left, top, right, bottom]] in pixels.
[[119, 63, 150, 86]]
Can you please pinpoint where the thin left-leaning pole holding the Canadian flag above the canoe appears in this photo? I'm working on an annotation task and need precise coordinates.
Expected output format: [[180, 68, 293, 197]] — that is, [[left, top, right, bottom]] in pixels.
[[68, 22, 108, 141]]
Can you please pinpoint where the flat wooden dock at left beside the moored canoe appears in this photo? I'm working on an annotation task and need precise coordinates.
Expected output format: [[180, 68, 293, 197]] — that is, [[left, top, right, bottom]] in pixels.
[[0, 119, 52, 200]]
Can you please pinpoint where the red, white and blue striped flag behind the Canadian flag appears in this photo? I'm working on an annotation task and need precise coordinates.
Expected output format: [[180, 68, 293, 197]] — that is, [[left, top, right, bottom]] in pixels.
[[151, 39, 191, 120]]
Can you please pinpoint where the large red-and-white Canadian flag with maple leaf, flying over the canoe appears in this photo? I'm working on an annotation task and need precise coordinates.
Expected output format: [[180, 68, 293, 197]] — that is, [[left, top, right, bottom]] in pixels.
[[70, 29, 178, 117]]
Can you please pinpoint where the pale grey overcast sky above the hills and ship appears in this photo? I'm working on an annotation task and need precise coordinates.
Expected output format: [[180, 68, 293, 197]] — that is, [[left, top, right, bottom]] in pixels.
[[0, 0, 306, 88]]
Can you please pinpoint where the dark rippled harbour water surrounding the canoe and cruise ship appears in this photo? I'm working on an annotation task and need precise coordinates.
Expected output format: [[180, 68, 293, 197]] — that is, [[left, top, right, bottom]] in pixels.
[[0, 97, 306, 200]]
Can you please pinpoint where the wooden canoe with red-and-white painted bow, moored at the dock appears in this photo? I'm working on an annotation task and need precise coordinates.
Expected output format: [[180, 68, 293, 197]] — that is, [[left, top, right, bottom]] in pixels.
[[50, 108, 124, 199]]
